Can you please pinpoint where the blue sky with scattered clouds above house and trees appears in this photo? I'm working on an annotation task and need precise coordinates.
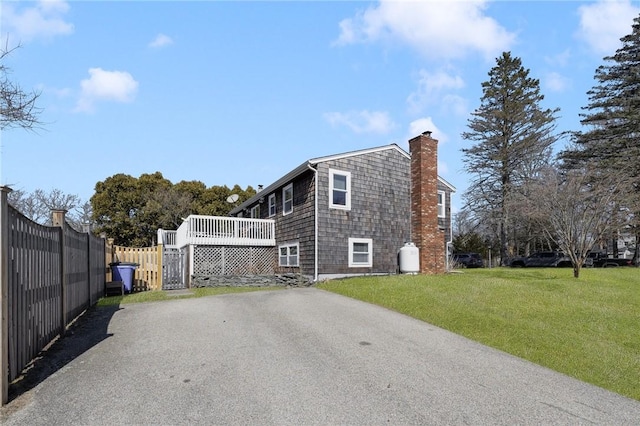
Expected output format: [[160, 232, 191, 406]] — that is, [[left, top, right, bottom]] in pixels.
[[0, 0, 640, 209]]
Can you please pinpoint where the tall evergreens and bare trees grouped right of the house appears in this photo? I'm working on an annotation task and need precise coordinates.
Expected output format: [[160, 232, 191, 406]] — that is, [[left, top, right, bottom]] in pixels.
[[453, 16, 640, 277]]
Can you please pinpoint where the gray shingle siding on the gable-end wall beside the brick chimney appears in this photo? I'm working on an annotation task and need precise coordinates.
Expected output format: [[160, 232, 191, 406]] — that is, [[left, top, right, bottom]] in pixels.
[[317, 149, 410, 275]]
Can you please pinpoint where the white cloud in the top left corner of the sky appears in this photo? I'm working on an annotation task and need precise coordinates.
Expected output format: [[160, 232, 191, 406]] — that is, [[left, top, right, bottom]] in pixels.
[[0, 0, 73, 42]]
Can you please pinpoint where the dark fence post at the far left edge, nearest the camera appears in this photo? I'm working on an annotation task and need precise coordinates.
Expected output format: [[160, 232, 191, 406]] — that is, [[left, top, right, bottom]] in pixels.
[[0, 186, 12, 405]]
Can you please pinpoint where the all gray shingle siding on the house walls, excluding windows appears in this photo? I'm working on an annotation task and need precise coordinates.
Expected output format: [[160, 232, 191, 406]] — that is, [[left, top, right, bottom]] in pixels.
[[235, 141, 451, 279]]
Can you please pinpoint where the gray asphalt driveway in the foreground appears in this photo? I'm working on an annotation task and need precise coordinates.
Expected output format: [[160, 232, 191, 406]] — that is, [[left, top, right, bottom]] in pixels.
[[2, 288, 640, 425]]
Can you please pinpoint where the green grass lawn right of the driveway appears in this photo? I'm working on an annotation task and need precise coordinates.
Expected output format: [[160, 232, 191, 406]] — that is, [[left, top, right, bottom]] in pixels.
[[318, 268, 640, 400]]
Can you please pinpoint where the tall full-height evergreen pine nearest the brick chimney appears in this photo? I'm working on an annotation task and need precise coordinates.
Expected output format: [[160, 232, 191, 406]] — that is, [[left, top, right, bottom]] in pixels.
[[462, 52, 558, 264]]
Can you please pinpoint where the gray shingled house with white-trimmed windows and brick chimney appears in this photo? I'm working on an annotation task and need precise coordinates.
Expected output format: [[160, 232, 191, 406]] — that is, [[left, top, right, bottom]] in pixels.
[[230, 132, 455, 281]]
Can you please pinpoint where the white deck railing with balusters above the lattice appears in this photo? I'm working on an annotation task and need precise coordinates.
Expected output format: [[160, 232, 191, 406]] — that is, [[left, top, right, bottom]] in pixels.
[[174, 215, 276, 248]]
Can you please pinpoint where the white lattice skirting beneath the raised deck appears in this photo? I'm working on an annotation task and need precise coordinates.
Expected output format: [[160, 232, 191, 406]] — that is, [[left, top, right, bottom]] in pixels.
[[191, 246, 277, 275]]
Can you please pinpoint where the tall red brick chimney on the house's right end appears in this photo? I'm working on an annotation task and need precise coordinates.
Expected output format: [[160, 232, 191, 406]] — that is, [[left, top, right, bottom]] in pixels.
[[409, 131, 445, 274]]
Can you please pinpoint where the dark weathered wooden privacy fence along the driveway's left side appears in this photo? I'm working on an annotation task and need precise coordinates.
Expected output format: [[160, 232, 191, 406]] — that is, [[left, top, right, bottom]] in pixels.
[[0, 186, 106, 404]]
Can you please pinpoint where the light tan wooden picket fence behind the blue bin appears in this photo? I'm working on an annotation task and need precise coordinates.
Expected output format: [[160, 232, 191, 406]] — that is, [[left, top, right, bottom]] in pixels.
[[106, 245, 162, 291]]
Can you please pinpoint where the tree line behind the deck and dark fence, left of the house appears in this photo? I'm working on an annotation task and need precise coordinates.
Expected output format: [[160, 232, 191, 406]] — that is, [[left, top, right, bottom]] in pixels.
[[8, 172, 256, 247]]
